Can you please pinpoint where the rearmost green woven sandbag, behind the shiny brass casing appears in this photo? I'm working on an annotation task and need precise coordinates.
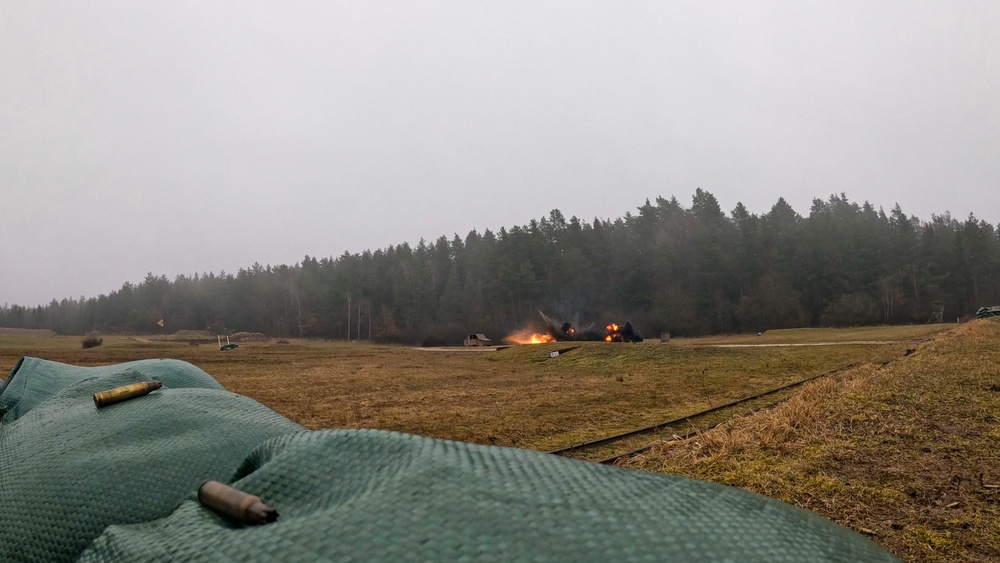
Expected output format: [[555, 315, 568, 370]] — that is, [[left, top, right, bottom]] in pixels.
[[0, 357, 224, 423]]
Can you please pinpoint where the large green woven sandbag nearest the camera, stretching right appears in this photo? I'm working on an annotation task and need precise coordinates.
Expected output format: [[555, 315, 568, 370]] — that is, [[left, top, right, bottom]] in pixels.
[[80, 430, 896, 563]]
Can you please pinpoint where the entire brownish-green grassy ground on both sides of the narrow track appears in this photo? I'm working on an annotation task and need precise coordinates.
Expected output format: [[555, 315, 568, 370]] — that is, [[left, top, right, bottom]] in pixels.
[[0, 321, 976, 561]]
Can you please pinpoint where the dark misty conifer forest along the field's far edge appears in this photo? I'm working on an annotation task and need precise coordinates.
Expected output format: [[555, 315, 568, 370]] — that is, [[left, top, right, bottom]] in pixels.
[[0, 189, 1000, 342]]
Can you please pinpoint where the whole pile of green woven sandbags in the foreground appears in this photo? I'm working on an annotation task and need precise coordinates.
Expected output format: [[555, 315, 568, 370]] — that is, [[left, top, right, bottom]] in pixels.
[[0, 358, 896, 562]]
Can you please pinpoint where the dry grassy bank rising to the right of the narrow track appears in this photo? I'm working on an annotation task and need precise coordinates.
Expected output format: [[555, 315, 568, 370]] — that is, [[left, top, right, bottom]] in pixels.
[[623, 321, 1000, 561]]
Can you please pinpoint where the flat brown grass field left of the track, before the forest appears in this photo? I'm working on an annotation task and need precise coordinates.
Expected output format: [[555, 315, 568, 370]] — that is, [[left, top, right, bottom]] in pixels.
[[0, 330, 905, 450]]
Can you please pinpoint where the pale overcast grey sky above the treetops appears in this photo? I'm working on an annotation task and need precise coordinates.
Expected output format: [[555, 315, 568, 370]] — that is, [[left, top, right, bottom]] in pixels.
[[0, 0, 1000, 305]]
